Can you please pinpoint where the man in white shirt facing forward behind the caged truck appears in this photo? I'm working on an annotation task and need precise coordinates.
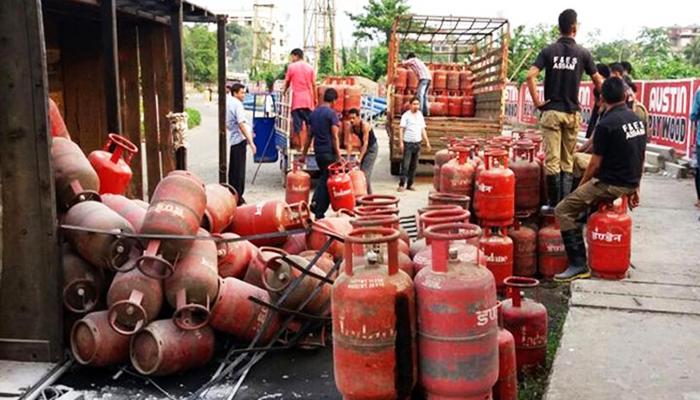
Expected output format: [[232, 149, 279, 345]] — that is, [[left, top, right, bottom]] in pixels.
[[398, 97, 431, 192]]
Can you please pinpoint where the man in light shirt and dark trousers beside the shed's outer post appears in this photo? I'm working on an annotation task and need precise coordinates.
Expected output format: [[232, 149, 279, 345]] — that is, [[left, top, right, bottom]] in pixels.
[[226, 83, 256, 205]]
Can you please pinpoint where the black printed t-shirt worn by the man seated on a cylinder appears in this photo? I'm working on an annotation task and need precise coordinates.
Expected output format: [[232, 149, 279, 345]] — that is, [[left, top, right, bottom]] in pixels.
[[593, 104, 647, 188]]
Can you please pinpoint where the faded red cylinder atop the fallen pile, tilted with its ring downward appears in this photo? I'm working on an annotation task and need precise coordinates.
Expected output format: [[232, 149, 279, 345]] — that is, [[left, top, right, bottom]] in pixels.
[[136, 170, 207, 279]]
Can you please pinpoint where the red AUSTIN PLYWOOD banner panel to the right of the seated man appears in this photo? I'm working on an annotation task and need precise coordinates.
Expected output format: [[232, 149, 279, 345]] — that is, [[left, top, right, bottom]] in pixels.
[[642, 79, 693, 154]]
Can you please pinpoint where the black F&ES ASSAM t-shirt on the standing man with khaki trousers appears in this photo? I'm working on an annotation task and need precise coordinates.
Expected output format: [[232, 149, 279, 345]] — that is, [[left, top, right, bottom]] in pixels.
[[533, 37, 597, 113]]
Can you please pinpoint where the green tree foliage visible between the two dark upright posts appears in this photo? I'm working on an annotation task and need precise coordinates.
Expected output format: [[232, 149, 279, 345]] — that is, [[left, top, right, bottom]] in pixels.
[[183, 24, 217, 84]]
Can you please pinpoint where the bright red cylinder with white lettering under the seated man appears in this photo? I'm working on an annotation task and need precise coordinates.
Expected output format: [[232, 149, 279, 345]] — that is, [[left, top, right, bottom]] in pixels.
[[586, 197, 632, 279]]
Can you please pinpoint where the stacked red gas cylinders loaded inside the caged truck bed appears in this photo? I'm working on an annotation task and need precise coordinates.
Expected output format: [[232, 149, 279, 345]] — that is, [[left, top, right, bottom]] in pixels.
[[392, 64, 476, 118]]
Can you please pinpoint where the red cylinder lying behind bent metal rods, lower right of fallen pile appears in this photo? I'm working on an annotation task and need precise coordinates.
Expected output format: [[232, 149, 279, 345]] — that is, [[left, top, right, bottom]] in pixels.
[[209, 278, 281, 345]]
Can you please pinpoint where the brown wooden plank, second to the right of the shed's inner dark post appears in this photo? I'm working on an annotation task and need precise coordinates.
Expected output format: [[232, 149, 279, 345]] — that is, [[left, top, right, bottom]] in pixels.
[[139, 24, 161, 198]]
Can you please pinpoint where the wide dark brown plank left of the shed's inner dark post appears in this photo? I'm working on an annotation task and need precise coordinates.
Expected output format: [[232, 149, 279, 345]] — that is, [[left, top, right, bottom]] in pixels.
[[61, 17, 108, 153]]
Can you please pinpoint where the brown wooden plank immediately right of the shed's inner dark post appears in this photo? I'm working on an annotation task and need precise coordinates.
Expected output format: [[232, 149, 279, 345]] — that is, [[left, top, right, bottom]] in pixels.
[[119, 23, 143, 199]]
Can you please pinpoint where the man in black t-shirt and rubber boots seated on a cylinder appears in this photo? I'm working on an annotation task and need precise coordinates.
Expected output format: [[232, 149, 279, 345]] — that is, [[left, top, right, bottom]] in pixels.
[[554, 77, 647, 281]]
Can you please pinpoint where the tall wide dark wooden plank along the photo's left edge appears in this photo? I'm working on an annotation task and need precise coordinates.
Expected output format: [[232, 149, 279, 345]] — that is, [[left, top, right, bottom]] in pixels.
[[0, 0, 64, 362]]
